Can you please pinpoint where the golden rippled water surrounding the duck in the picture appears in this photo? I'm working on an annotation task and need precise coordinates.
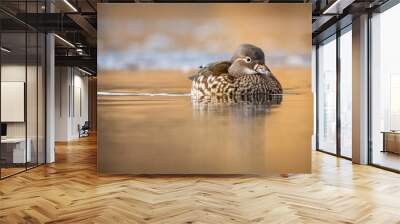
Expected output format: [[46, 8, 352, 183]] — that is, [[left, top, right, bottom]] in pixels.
[[98, 68, 313, 174]]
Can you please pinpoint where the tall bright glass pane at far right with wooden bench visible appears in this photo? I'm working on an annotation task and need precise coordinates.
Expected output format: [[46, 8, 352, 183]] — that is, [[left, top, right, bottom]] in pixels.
[[370, 4, 400, 171]]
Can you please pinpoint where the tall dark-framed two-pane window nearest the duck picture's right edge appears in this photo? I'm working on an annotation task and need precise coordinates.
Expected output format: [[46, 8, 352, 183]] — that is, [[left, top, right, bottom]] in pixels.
[[317, 25, 352, 158]]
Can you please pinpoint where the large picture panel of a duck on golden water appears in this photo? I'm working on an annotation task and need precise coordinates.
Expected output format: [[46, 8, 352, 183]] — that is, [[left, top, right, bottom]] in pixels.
[[98, 3, 313, 175]]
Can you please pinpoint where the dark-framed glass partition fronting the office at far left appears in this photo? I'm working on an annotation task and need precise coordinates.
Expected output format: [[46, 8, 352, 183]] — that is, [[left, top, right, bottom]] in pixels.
[[0, 1, 46, 179]]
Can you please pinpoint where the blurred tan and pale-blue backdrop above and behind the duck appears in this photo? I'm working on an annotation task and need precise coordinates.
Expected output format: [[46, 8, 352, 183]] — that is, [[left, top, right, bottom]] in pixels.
[[98, 4, 311, 91]]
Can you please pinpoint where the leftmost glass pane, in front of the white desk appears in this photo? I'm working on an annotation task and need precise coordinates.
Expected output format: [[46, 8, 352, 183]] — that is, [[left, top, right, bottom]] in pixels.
[[0, 32, 27, 177]]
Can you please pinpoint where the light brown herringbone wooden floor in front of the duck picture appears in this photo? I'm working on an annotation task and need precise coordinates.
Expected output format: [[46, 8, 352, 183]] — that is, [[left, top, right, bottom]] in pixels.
[[0, 137, 400, 224]]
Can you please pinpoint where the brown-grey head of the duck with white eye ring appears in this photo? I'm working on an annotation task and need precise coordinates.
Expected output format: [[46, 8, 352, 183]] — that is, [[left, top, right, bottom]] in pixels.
[[228, 44, 269, 76]]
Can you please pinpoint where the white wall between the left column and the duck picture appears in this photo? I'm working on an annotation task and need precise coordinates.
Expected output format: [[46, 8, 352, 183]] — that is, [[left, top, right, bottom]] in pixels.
[[55, 67, 88, 141]]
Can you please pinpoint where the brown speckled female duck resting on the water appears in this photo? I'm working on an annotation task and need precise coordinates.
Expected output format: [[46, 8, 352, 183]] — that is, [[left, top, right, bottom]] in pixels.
[[190, 44, 282, 97]]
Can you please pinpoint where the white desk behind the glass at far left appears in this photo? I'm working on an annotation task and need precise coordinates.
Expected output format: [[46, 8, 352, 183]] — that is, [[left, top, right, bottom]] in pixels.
[[1, 138, 32, 163]]
